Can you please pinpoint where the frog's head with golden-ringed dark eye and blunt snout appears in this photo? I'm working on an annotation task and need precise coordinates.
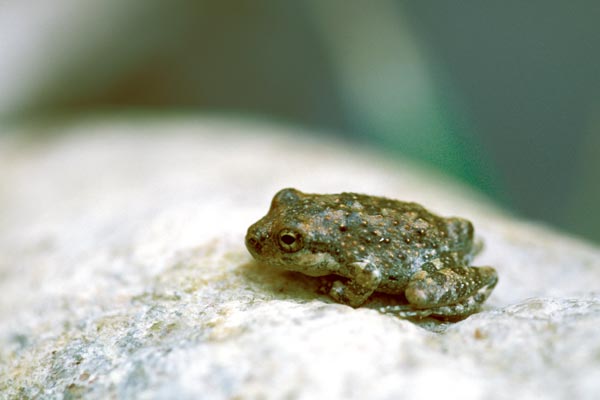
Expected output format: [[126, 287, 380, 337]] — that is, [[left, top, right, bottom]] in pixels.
[[246, 188, 335, 276]]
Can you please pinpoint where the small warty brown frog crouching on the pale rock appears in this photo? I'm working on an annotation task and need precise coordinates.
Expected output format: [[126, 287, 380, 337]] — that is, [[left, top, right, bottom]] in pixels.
[[245, 188, 498, 319]]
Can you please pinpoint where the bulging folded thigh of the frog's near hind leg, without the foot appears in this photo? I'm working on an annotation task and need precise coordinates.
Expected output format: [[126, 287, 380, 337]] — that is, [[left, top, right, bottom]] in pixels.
[[404, 266, 498, 308]]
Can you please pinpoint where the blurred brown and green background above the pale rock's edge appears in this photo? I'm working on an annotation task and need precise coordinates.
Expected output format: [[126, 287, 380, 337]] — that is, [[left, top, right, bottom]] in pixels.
[[0, 0, 600, 243]]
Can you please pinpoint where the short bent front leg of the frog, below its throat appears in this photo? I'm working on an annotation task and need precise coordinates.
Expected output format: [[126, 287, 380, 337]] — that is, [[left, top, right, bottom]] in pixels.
[[329, 261, 381, 307]]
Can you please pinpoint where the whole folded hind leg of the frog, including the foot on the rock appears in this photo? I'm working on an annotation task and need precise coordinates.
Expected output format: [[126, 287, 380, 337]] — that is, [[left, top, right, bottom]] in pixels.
[[386, 266, 498, 318]]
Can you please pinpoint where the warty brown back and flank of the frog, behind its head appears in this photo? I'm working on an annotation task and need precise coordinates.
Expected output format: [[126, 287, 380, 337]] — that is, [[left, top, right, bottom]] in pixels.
[[316, 193, 473, 293]]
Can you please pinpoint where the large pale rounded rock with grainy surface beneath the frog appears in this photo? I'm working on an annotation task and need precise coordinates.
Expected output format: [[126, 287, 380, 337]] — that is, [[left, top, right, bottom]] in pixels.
[[0, 120, 600, 399]]
